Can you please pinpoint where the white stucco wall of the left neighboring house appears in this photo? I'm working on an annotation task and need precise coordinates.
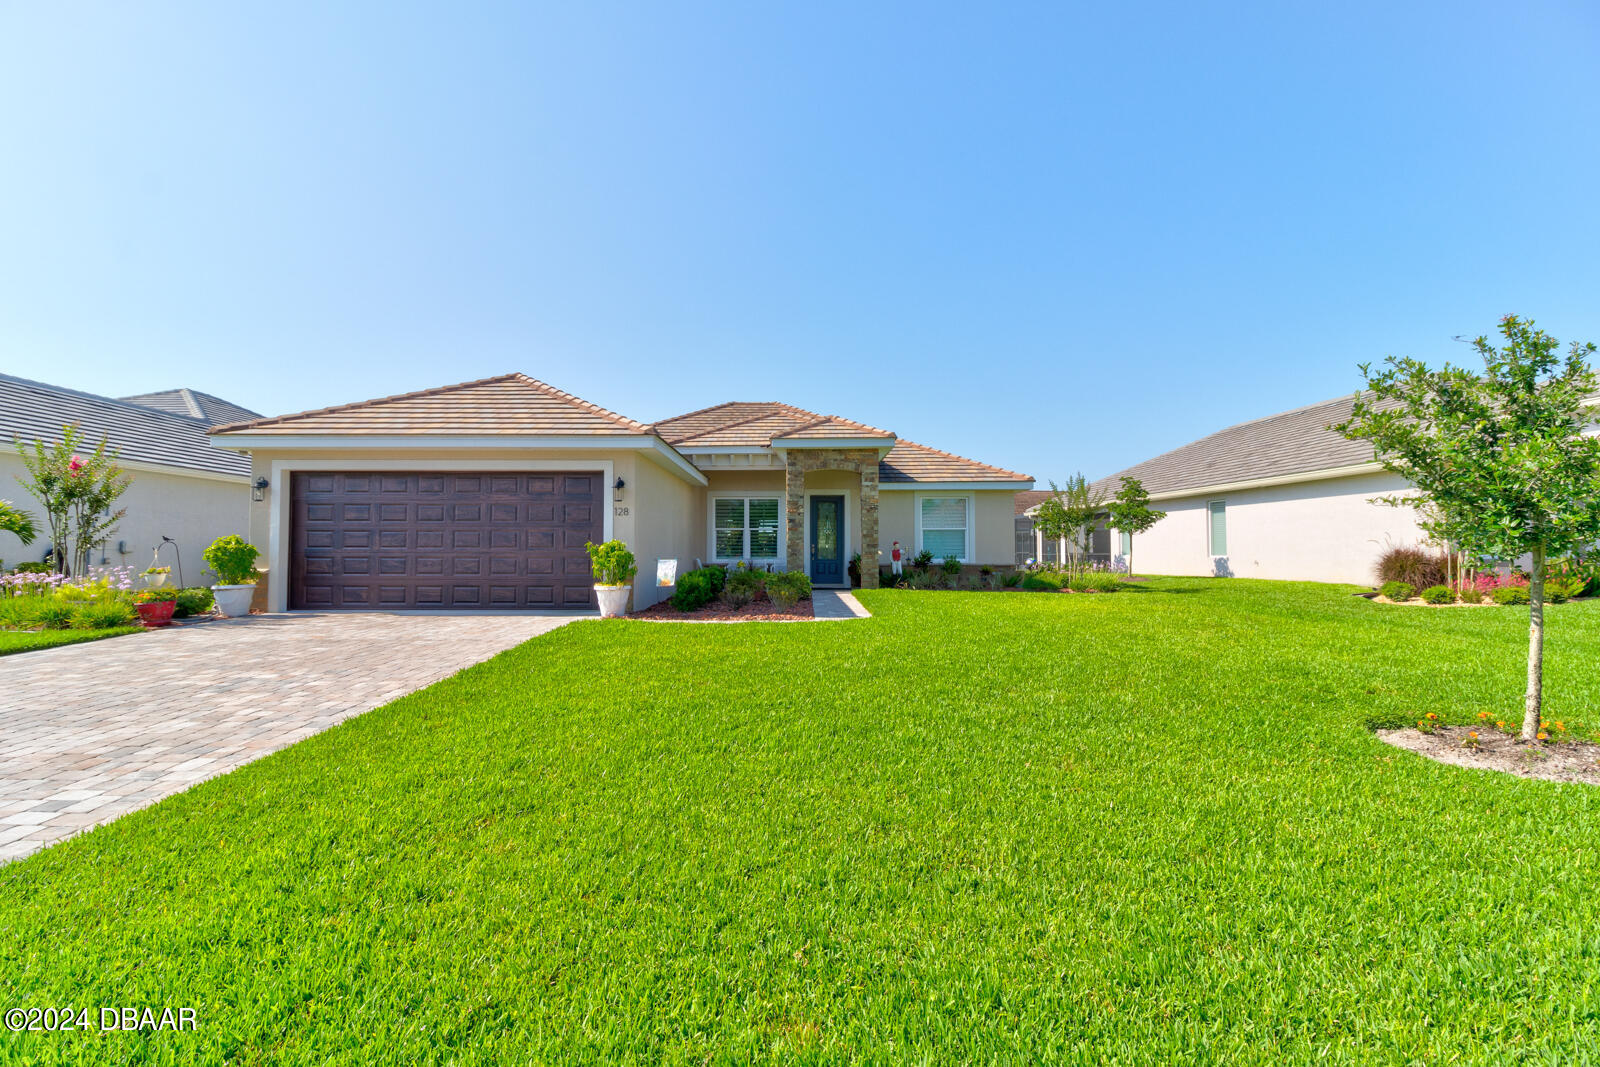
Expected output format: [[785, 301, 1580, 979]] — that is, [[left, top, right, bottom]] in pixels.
[[0, 453, 250, 585]]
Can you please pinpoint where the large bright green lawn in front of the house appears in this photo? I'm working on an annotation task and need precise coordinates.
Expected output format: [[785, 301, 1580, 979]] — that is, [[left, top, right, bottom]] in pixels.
[[0, 579, 1600, 1064]]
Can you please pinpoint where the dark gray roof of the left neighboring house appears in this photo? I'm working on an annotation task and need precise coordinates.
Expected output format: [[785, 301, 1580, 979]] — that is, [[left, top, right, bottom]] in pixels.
[[0, 374, 250, 477]]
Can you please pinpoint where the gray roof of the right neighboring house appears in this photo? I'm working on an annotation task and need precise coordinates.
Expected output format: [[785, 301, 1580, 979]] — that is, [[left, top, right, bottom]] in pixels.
[[1094, 397, 1373, 494]]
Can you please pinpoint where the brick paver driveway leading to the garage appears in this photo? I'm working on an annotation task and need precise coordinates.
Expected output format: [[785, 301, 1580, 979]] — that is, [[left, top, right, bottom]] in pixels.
[[0, 614, 581, 862]]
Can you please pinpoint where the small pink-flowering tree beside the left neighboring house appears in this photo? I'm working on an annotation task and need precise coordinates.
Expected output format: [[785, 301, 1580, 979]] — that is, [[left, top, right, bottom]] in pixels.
[[16, 422, 133, 574]]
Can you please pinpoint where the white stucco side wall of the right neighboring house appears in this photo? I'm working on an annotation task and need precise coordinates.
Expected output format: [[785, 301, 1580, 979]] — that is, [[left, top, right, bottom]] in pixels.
[[1114, 472, 1426, 585]]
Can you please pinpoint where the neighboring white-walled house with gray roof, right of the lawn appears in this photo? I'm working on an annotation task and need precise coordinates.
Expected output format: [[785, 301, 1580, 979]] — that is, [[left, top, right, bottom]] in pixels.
[[1036, 397, 1427, 585]]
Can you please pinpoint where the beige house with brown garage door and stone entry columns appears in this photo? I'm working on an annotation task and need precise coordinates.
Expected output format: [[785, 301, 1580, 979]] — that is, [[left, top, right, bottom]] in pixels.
[[211, 374, 1034, 611]]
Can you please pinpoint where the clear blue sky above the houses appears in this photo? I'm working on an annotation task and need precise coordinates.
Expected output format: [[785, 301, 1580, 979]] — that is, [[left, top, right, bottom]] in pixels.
[[0, 0, 1600, 478]]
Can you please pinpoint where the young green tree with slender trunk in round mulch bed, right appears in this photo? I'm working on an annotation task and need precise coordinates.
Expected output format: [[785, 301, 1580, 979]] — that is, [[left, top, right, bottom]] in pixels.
[[1334, 315, 1600, 741]]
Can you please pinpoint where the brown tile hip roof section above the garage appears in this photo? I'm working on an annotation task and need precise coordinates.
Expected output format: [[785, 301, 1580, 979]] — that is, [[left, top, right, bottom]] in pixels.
[[211, 374, 650, 435]]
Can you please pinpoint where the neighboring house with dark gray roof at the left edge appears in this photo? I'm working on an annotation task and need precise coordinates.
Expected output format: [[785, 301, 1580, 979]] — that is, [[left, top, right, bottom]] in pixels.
[[0, 374, 259, 585]]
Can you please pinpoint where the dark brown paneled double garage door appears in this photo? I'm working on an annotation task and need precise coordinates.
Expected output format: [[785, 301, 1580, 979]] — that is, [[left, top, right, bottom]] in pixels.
[[290, 470, 605, 609]]
